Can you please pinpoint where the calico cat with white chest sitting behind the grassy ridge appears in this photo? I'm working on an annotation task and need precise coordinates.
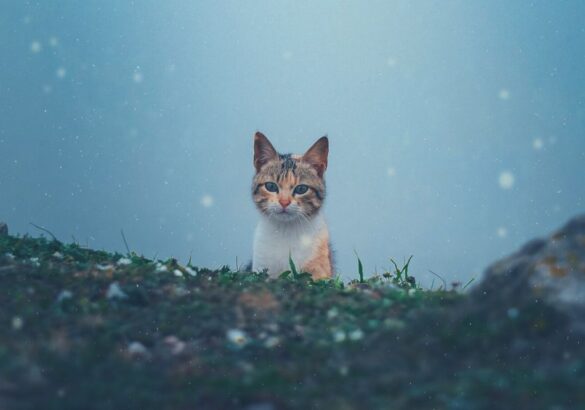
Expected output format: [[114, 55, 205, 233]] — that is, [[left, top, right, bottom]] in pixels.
[[252, 132, 333, 279]]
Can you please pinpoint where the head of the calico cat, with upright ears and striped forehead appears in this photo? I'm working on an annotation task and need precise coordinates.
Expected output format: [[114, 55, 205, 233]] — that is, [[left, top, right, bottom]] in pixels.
[[252, 132, 329, 222]]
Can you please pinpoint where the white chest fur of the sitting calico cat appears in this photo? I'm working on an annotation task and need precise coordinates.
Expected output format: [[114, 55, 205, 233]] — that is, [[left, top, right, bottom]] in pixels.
[[252, 215, 326, 277]]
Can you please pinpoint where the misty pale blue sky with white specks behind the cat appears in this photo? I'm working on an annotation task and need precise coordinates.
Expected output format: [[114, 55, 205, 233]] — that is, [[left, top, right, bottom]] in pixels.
[[0, 0, 585, 284]]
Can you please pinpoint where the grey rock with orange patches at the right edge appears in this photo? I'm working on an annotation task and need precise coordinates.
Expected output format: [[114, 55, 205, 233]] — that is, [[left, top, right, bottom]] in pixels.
[[474, 215, 585, 333]]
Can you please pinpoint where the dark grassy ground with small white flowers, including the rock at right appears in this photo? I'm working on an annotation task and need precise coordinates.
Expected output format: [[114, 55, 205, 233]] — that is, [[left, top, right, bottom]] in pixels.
[[0, 217, 585, 410]]
